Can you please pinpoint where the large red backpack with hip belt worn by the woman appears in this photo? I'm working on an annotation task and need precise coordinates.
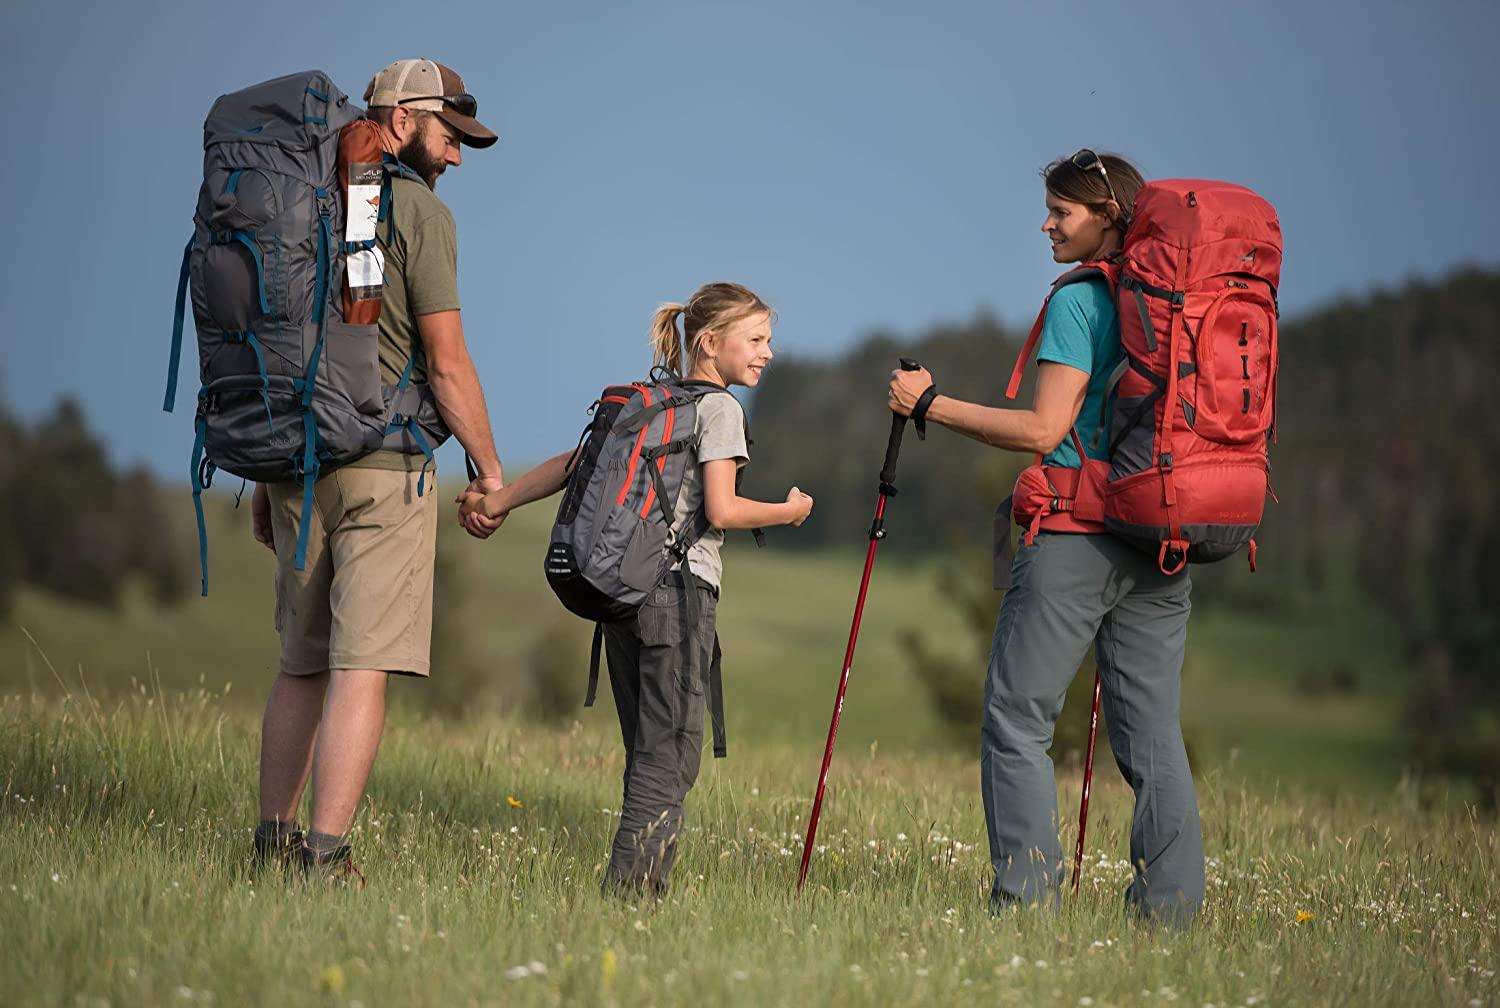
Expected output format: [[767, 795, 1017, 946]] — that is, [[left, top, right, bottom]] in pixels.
[[996, 179, 1281, 587]]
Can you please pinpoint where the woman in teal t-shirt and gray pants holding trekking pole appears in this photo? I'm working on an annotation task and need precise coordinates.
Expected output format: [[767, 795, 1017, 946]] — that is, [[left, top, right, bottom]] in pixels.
[[888, 150, 1203, 924]]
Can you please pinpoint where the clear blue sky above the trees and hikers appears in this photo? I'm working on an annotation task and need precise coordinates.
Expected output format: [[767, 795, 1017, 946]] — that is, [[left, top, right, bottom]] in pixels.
[[0, 0, 1500, 477]]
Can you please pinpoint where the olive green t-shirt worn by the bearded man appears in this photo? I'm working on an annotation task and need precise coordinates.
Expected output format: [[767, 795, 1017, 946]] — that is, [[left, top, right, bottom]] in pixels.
[[350, 177, 459, 471]]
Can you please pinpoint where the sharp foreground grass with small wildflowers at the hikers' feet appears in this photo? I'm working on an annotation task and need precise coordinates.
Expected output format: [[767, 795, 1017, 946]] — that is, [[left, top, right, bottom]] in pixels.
[[0, 687, 1500, 1008]]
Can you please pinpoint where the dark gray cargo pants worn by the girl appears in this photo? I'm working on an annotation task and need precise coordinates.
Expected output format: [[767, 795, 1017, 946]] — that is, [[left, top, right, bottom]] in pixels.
[[605, 582, 717, 897]]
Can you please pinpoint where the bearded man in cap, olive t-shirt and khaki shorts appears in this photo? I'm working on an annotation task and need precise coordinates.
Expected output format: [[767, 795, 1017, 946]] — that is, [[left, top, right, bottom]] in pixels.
[[254, 60, 503, 872]]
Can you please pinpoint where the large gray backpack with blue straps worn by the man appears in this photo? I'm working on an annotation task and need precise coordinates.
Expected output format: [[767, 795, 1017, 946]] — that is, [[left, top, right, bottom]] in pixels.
[[162, 71, 449, 594]]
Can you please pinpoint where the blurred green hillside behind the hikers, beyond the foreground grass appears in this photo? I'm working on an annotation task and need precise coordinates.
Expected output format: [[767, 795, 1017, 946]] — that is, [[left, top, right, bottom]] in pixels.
[[0, 491, 1406, 794]]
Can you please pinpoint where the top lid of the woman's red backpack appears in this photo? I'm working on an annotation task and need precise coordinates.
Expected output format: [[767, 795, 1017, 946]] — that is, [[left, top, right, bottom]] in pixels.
[[1124, 179, 1281, 288]]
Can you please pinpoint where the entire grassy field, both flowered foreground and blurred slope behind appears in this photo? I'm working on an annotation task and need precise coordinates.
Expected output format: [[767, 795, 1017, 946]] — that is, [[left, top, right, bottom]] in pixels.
[[0, 486, 1500, 1008]]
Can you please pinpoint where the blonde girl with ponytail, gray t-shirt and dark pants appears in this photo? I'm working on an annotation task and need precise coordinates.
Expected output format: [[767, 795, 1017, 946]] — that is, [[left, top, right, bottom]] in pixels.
[[461, 284, 813, 899]]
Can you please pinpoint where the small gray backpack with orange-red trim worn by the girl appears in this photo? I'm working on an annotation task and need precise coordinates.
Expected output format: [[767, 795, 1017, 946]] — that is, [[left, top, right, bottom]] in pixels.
[[545, 376, 764, 756]]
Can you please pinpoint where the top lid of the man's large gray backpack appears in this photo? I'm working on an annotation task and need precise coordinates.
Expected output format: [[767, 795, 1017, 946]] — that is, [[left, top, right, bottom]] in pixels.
[[203, 71, 365, 150]]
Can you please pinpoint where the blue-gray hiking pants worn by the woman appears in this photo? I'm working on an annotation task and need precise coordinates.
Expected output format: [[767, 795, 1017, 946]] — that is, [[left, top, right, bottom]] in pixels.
[[980, 533, 1203, 926]]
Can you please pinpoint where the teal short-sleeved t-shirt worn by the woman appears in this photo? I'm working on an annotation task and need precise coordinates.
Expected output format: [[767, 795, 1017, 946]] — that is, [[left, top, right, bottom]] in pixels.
[[1037, 279, 1122, 470]]
